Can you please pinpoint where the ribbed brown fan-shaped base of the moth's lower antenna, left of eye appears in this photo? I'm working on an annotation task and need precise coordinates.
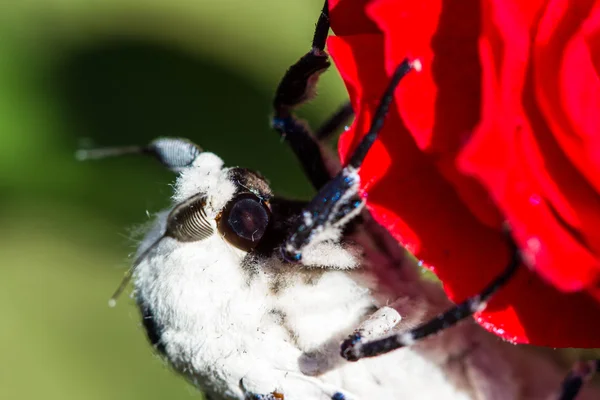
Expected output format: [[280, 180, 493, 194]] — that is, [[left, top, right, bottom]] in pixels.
[[165, 195, 214, 242]]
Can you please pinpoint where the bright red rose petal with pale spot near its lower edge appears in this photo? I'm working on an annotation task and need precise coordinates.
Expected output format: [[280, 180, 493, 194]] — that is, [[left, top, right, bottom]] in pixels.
[[462, 2, 600, 291]]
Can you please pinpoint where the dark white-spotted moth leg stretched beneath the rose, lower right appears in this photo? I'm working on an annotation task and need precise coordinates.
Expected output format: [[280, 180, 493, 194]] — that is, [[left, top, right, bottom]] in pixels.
[[341, 239, 521, 361]]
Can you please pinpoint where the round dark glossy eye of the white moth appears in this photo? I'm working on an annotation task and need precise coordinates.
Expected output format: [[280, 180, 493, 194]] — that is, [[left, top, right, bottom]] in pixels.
[[217, 193, 271, 251]]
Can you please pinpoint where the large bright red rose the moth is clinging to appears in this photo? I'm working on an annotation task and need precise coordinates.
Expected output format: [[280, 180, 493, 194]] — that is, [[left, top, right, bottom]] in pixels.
[[328, 0, 600, 347]]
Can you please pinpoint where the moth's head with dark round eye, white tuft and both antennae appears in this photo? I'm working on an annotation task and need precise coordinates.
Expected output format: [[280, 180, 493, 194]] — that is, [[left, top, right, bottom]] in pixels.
[[77, 138, 273, 305]]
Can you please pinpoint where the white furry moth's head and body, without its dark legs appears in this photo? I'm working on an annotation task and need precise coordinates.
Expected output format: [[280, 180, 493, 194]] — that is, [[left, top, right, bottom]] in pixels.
[[81, 138, 592, 400]]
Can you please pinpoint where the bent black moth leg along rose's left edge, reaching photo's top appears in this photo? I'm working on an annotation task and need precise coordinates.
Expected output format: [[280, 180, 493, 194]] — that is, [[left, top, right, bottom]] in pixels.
[[272, 1, 353, 190]]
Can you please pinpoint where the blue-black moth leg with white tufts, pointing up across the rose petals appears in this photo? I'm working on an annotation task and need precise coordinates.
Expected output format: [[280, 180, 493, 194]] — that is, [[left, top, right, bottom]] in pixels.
[[282, 59, 419, 262]]
